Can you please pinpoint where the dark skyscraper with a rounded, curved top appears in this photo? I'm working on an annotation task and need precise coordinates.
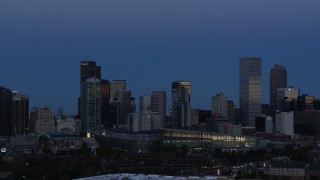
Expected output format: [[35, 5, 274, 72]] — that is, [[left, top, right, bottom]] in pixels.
[[270, 64, 287, 109]]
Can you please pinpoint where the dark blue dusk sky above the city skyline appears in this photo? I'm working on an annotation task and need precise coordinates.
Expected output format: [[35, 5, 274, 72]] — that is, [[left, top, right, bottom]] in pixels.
[[0, 0, 320, 113]]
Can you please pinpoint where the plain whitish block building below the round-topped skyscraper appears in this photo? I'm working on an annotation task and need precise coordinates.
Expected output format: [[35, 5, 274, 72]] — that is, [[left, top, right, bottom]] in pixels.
[[275, 111, 294, 136]]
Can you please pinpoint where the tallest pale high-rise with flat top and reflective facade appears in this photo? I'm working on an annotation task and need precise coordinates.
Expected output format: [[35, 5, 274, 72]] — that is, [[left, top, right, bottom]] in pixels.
[[239, 57, 262, 126]]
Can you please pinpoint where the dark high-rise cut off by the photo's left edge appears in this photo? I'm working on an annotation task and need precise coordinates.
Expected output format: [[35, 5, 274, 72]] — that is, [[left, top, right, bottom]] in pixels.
[[0, 86, 14, 136]]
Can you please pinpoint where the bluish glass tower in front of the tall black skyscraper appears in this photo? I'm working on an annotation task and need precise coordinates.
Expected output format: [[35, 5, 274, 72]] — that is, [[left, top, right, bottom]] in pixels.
[[81, 78, 102, 132]]
